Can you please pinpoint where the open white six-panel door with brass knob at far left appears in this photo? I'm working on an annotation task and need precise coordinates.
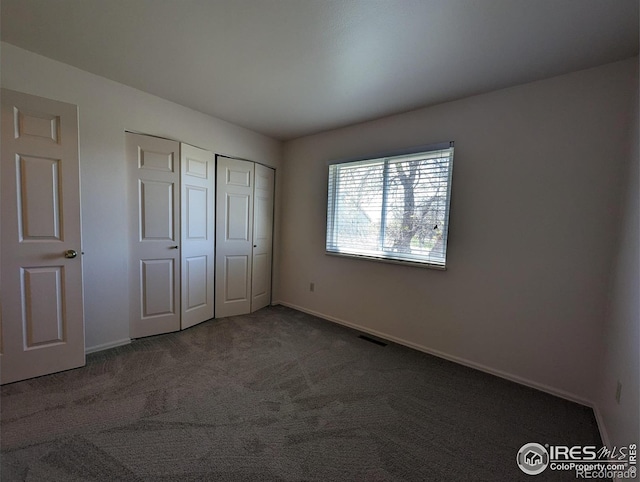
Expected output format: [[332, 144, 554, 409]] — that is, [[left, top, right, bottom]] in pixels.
[[0, 89, 85, 383]]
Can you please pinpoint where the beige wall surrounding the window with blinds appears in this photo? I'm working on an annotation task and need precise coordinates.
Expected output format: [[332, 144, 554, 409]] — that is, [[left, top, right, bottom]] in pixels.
[[279, 60, 637, 403]]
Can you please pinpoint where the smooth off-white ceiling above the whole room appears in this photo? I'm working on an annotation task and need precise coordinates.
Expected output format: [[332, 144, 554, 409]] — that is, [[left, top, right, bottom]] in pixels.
[[1, 0, 638, 139]]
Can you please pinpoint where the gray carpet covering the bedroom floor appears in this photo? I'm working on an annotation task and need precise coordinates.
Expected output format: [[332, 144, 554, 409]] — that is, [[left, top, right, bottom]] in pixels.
[[0, 306, 601, 482]]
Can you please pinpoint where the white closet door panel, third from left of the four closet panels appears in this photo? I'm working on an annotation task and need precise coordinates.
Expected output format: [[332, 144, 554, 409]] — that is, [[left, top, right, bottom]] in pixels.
[[215, 156, 254, 318]]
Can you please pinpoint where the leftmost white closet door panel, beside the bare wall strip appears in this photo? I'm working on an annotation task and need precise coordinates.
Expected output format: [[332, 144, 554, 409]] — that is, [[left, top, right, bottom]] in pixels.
[[126, 133, 180, 338]]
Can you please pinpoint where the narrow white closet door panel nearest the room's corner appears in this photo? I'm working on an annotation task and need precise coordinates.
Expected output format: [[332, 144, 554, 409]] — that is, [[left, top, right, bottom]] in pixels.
[[251, 164, 275, 312]]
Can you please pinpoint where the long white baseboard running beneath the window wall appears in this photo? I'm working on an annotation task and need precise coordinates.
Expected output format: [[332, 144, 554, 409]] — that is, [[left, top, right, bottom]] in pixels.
[[273, 301, 606, 406]]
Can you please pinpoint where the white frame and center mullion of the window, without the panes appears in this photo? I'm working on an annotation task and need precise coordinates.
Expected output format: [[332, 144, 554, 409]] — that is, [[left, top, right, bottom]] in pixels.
[[325, 142, 453, 270]]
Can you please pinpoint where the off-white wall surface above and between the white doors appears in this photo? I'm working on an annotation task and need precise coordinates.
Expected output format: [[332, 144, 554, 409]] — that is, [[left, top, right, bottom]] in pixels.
[[1, 43, 281, 350]]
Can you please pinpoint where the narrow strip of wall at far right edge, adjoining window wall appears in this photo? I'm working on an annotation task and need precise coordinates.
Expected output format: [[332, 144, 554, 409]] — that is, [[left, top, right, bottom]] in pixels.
[[596, 71, 640, 447]]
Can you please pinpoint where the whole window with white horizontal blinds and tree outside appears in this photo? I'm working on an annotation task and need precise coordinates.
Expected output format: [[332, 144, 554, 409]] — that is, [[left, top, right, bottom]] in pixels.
[[326, 143, 453, 269]]
